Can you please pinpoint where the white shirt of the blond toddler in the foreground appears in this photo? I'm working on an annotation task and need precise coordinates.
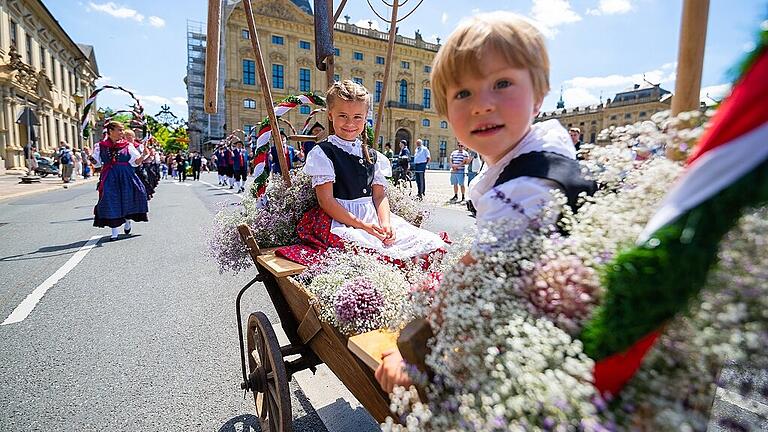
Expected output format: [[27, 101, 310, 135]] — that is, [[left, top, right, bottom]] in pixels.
[[469, 120, 576, 227]]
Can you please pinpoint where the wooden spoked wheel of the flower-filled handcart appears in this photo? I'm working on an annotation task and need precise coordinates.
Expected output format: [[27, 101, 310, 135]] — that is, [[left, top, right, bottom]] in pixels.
[[247, 312, 292, 432]]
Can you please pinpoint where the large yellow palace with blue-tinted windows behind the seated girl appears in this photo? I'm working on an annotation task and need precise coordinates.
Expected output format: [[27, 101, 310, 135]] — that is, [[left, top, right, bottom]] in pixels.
[[221, 0, 456, 164]]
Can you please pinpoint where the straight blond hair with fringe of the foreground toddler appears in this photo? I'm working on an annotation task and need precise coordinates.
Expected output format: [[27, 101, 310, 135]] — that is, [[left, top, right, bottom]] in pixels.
[[430, 11, 549, 116]]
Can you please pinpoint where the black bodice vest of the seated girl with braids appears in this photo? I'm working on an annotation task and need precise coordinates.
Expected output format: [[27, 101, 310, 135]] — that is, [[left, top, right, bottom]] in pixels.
[[317, 141, 376, 200]]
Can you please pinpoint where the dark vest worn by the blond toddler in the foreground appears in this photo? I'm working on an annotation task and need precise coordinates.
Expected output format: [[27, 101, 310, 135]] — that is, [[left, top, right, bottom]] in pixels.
[[493, 152, 597, 213]]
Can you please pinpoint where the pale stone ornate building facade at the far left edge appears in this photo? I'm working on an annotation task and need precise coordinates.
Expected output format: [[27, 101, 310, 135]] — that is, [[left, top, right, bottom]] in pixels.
[[0, 0, 99, 171]]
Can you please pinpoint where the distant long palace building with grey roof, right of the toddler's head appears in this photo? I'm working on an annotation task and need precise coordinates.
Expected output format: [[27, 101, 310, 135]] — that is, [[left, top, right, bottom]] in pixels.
[[534, 84, 672, 144]]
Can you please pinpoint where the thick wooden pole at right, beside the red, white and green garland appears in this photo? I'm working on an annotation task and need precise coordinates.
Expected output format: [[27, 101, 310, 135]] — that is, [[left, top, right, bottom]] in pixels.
[[672, 0, 709, 116]]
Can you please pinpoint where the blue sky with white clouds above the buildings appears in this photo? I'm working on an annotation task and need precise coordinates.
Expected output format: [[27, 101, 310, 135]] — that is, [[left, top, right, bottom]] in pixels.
[[44, 0, 768, 117]]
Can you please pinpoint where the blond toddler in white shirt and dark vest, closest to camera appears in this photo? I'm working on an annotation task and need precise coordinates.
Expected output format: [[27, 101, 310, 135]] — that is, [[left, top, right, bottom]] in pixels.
[[375, 12, 595, 392]]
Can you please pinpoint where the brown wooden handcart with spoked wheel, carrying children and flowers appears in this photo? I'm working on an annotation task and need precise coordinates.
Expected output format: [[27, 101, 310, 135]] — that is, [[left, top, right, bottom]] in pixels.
[[236, 225, 394, 431]]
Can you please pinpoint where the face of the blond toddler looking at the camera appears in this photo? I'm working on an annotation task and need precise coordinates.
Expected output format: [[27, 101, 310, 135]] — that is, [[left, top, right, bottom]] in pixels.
[[446, 52, 541, 163]]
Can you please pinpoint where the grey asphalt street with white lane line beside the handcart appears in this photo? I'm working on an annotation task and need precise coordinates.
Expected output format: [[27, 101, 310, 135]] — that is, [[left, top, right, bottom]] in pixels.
[[0, 174, 473, 431]]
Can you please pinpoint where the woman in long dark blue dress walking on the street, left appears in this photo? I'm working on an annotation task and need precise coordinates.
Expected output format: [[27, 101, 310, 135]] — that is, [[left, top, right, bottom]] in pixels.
[[93, 121, 149, 240]]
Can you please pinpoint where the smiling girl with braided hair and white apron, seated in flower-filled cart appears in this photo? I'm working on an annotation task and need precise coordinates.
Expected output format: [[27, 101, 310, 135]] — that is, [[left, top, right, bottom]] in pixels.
[[278, 80, 446, 262]]
